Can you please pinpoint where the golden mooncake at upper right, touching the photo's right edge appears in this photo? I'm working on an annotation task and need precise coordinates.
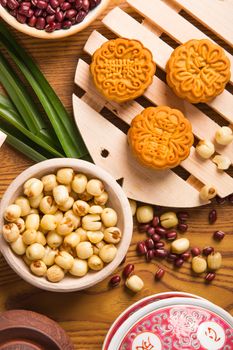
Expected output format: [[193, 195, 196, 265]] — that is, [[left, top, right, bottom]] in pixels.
[[166, 39, 230, 103]]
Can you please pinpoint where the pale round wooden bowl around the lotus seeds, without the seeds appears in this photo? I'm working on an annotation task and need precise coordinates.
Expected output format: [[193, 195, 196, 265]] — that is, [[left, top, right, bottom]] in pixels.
[[0, 158, 133, 292]]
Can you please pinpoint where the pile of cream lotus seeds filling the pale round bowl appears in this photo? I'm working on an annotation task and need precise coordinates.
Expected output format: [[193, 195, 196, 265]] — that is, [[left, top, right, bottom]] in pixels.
[[2, 168, 122, 282]]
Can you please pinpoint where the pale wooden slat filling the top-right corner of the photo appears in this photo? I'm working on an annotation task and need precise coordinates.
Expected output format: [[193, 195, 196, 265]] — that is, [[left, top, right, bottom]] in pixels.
[[172, 0, 233, 46]]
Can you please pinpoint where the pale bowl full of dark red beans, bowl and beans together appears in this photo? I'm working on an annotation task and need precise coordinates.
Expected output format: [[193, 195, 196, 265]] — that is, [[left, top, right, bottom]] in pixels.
[[0, 0, 110, 39]]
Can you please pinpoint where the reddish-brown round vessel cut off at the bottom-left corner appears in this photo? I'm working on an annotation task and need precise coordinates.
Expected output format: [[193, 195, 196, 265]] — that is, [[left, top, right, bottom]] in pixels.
[[0, 310, 74, 350]]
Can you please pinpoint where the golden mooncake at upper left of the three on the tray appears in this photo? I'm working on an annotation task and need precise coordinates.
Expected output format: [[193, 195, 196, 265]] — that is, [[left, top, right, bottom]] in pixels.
[[90, 38, 156, 103]]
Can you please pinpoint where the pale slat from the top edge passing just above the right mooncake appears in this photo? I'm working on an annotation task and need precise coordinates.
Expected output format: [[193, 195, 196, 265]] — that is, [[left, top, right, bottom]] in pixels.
[[127, 0, 233, 83]]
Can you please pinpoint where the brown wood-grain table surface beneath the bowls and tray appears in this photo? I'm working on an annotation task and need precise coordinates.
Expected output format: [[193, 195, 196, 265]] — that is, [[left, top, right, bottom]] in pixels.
[[0, 0, 233, 350]]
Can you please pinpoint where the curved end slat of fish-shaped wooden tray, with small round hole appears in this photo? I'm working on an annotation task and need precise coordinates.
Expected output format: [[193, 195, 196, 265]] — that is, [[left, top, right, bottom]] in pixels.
[[73, 95, 201, 207]]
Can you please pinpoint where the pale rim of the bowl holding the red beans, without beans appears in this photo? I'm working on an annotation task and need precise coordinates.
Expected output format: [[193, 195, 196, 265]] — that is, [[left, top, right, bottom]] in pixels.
[[0, 0, 110, 39]]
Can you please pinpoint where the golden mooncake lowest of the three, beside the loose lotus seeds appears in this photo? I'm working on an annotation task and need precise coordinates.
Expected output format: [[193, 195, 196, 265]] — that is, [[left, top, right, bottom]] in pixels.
[[128, 106, 194, 170]]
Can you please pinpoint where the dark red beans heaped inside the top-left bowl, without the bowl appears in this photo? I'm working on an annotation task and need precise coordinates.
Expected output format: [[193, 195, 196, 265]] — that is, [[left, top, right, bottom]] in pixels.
[[0, 0, 101, 33]]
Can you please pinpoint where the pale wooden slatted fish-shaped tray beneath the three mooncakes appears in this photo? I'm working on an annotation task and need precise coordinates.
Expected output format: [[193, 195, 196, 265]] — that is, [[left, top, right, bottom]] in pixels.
[[73, 0, 233, 207]]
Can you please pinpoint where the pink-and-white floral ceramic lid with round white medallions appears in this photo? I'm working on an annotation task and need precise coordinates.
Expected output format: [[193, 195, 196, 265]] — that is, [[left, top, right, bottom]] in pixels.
[[104, 297, 233, 350]]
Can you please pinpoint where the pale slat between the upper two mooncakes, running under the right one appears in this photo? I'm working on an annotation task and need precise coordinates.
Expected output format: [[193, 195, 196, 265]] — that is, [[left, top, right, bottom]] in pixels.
[[103, 7, 233, 123]]
